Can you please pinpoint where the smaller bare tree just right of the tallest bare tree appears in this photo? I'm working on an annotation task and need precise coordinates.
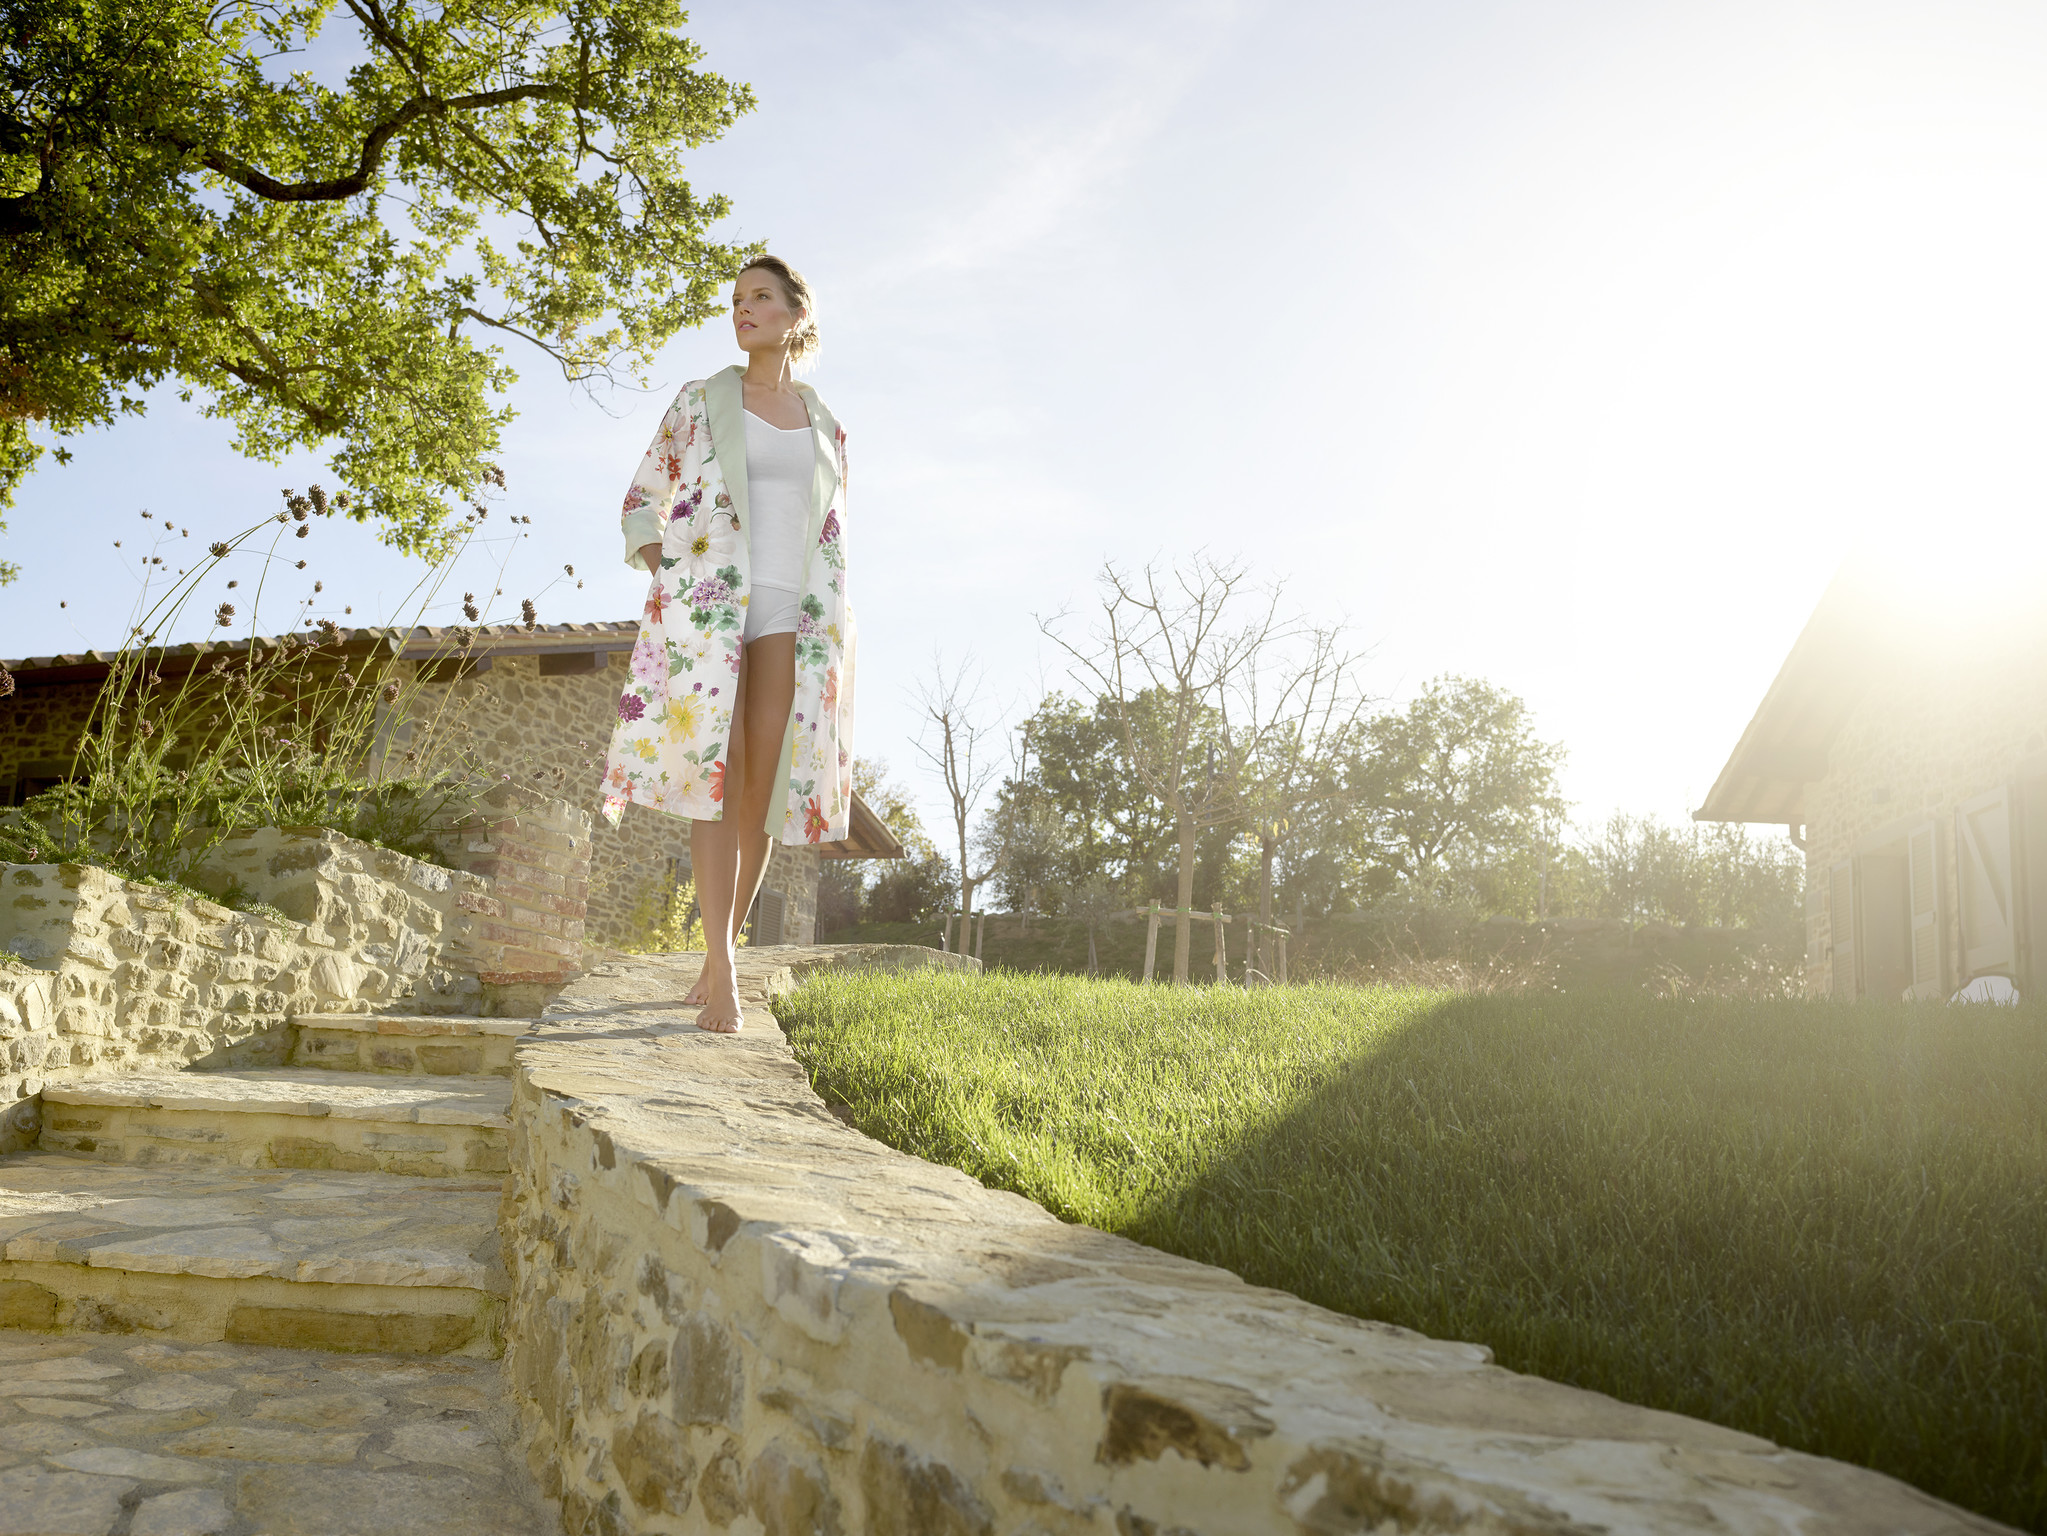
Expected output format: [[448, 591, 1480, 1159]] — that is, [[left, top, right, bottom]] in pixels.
[[1238, 625, 1369, 975]]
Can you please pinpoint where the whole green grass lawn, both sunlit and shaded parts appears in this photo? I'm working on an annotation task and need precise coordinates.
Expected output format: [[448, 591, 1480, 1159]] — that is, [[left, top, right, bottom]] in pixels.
[[776, 971, 2047, 1532]]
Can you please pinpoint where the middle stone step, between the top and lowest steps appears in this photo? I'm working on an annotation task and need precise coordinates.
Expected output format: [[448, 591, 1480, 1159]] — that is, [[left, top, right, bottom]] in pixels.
[[37, 1067, 512, 1178]]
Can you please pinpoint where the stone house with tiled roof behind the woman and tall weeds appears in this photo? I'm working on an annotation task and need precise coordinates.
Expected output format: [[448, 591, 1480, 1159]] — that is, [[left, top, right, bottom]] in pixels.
[[0, 621, 905, 944]]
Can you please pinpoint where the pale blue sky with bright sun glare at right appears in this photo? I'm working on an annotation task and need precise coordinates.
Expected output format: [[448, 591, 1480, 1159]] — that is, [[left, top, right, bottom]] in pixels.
[[0, 0, 2047, 843]]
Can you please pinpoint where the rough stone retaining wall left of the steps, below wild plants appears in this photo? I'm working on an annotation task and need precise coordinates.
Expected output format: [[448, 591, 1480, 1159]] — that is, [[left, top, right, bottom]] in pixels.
[[0, 819, 587, 1151]]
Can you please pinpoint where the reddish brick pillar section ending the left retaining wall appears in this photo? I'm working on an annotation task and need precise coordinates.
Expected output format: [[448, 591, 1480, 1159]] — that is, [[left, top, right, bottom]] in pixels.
[[442, 784, 592, 987]]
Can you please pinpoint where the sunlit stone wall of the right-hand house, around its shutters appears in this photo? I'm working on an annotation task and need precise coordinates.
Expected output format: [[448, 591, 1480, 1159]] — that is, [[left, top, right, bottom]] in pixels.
[[1805, 625, 2047, 997]]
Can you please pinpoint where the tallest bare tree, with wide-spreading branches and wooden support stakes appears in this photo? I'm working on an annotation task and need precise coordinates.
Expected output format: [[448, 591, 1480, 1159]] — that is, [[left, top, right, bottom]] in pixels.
[[1038, 553, 1294, 985]]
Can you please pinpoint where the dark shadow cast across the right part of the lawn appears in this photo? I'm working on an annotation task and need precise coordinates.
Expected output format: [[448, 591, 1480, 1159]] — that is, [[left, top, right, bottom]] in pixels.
[[1129, 995, 2047, 1532]]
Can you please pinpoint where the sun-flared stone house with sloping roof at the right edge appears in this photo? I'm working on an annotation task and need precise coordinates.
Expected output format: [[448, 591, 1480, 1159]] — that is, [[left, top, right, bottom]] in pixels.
[[1695, 571, 2047, 999]]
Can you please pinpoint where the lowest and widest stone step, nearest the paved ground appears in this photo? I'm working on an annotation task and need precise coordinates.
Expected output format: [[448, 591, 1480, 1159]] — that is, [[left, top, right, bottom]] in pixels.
[[0, 1153, 506, 1356]]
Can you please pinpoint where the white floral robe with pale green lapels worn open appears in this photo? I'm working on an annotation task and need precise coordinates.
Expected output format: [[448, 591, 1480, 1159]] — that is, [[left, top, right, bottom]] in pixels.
[[604, 367, 854, 844]]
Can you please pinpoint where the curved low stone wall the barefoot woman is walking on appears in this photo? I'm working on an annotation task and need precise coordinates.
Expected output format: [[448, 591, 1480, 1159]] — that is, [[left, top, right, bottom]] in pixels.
[[502, 946, 2000, 1536]]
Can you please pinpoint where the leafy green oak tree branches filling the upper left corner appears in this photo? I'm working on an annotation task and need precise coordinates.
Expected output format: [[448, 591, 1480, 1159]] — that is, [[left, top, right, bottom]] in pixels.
[[0, 0, 753, 580]]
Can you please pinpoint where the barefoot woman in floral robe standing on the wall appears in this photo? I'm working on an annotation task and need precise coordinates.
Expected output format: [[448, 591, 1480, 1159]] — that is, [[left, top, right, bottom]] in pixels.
[[604, 256, 854, 1034]]
